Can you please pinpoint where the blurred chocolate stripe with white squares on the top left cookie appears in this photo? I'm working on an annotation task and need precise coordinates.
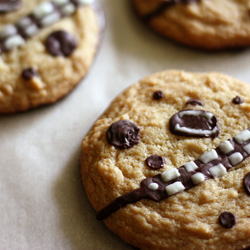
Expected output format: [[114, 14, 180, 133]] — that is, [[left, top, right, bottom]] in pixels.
[[0, 0, 92, 54]]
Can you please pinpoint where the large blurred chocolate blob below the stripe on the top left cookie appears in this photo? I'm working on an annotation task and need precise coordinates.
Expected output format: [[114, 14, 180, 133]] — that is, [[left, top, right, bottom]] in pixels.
[[45, 30, 77, 57]]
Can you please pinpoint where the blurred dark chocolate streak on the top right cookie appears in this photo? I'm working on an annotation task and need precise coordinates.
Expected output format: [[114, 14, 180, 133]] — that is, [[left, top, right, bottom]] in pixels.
[[143, 0, 201, 23]]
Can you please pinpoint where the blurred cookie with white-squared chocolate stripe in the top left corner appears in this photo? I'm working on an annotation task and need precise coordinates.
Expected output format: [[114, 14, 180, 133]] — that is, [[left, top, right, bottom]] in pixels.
[[0, 0, 104, 113]]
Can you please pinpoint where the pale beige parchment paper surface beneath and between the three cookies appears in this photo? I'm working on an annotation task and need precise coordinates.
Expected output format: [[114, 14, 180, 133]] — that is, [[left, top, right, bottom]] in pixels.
[[0, 0, 250, 250]]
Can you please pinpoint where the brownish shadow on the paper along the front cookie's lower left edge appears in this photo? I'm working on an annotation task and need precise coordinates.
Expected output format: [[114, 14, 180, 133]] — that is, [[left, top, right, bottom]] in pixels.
[[53, 146, 134, 250]]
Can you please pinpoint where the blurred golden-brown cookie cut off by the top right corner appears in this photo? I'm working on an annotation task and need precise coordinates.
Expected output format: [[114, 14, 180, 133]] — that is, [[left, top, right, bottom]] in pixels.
[[132, 0, 250, 50]]
